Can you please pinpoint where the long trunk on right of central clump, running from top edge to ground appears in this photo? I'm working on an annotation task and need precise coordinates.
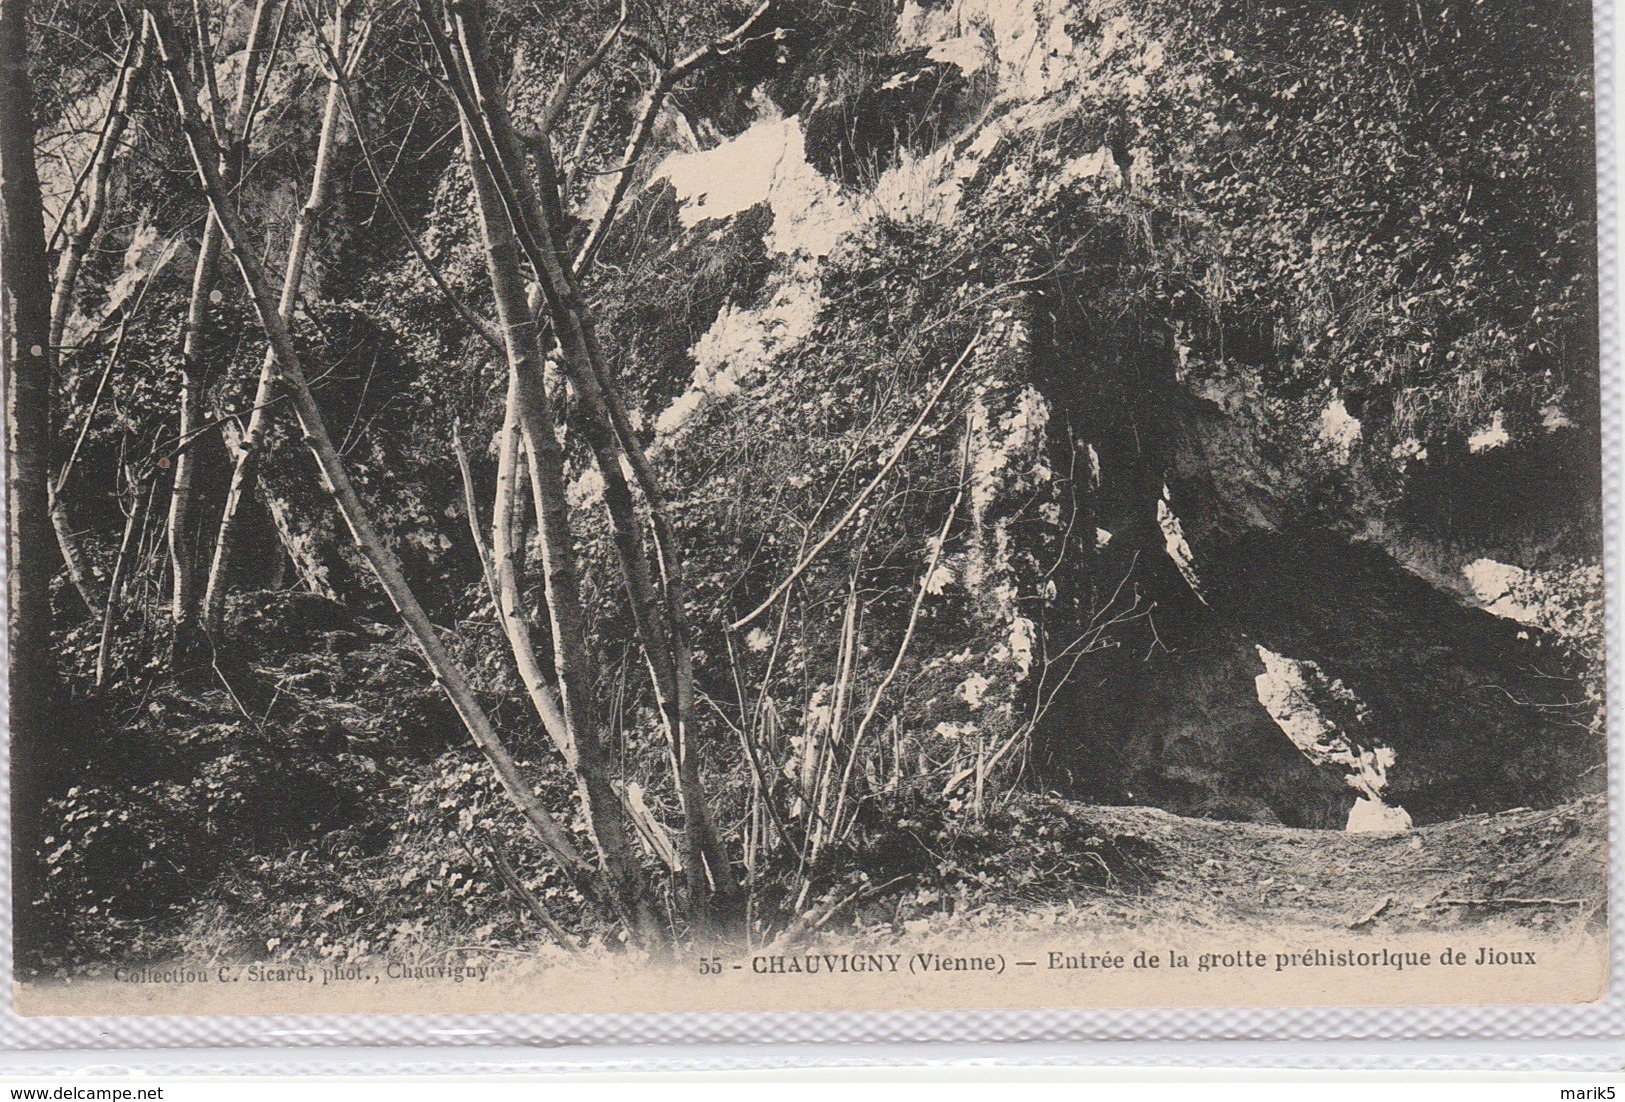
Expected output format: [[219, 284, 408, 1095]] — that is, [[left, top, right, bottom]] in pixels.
[[442, 0, 743, 926]]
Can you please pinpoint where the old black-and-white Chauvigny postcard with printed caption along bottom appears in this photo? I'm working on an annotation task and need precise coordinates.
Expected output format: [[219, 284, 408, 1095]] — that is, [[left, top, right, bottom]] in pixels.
[[0, 0, 1610, 1016]]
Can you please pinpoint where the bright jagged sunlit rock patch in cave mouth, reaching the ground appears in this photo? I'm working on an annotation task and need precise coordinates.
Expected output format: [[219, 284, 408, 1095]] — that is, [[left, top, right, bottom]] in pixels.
[[1253, 644, 1411, 834]]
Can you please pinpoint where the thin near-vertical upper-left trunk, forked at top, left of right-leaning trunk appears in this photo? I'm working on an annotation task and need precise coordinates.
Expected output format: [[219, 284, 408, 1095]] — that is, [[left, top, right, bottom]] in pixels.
[[169, 0, 276, 665]]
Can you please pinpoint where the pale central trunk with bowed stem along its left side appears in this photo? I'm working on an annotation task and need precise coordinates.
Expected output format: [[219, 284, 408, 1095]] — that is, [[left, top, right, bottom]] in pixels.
[[463, 119, 653, 942]]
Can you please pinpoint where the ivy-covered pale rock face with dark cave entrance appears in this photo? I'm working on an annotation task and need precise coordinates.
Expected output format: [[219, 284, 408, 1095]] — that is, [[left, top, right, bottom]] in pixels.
[[585, 0, 1602, 831]]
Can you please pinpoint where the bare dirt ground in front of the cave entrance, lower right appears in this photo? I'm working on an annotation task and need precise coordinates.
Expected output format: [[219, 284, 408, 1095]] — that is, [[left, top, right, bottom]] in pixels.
[[965, 796, 1607, 935]]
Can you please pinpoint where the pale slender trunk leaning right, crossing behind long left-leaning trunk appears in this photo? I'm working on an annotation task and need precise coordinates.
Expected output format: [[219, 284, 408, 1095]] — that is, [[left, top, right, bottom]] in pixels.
[[203, 0, 348, 631]]
